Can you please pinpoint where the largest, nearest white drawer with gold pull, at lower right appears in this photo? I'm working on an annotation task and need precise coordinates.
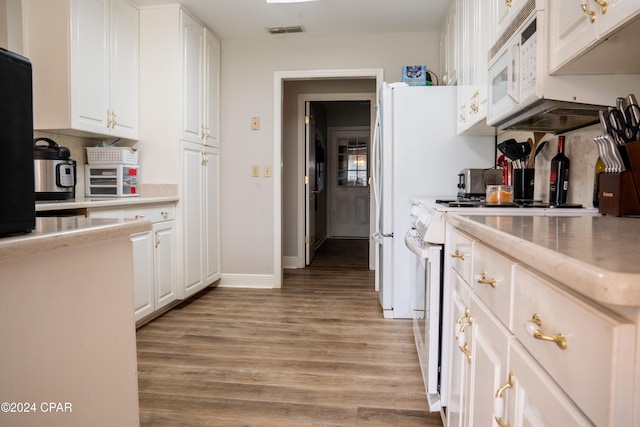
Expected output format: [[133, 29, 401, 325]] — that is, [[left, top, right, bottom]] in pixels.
[[513, 265, 635, 425]]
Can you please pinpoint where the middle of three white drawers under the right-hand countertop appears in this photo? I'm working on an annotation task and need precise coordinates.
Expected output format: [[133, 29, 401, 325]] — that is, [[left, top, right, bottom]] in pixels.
[[471, 242, 514, 327]]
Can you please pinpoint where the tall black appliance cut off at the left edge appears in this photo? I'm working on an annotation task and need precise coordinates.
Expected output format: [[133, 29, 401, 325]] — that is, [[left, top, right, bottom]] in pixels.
[[0, 48, 36, 235]]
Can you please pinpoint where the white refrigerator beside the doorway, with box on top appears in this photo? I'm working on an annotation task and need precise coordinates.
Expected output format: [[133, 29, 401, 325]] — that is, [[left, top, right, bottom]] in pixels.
[[372, 83, 495, 319]]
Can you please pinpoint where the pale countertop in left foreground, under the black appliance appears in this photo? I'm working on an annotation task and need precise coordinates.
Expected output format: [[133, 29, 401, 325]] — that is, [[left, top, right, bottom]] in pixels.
[[0, 217, 151, 262]]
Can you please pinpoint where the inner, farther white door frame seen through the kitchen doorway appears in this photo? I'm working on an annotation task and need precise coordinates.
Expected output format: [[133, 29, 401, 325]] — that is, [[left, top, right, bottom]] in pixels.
[[296, 92, 376, 268]]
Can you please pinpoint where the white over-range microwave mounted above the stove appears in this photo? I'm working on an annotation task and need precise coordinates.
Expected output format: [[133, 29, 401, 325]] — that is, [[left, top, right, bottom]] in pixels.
[[487, 0, 640, 134]]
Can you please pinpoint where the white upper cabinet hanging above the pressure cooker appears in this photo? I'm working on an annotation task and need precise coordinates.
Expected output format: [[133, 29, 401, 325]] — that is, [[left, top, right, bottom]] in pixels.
[[23, 0, 139, 140]]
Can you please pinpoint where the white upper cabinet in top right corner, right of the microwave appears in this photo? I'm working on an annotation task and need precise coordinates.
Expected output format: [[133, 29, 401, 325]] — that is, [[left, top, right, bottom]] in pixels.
[[548, 0, 640, 74]]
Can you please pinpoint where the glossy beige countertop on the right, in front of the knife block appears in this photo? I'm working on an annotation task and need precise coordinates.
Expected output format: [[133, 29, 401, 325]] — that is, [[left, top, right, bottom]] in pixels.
[[446, 213, 640, 307]]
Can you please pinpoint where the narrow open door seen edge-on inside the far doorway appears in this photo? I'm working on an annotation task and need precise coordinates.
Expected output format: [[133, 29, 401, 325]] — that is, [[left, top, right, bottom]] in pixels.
[[304, 101, 318, 265]]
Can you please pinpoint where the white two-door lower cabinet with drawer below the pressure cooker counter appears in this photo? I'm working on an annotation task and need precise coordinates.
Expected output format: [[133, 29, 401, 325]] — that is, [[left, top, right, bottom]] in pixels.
[[88, 204, 177, 321]]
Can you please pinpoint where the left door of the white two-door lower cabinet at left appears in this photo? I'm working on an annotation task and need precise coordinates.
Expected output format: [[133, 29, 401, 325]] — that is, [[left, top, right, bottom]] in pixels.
[[131, 231, 154, 321]]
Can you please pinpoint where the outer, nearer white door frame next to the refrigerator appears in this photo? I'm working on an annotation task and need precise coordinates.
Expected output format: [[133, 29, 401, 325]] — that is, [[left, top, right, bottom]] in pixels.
[[273, 68, 384, 288]]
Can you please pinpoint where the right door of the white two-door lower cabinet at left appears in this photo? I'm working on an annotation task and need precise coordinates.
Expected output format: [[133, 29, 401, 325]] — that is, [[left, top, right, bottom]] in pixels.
[[153, 221, 177, 310]]
